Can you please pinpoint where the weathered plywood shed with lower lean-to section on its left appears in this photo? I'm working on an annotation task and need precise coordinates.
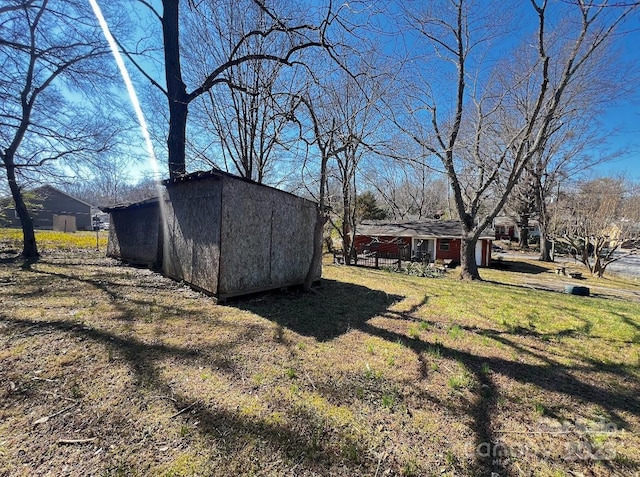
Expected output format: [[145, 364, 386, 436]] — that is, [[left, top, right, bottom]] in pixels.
[[104, 171, 321, 300]]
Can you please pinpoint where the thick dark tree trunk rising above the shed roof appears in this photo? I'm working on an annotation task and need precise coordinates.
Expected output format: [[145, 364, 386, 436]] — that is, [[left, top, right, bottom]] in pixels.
[[162, 0, 190, 179]]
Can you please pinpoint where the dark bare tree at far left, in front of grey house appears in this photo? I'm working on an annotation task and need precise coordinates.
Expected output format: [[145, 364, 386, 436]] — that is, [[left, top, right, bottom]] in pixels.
[[0, 0, 113, 258]]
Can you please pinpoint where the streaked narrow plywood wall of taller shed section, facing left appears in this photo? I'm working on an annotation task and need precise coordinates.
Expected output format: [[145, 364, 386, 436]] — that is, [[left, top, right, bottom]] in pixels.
[[163, 177, 222, 295]]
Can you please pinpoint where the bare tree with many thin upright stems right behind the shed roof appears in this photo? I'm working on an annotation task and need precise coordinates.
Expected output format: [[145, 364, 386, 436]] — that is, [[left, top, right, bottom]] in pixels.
[[185, 1, 299, 183]]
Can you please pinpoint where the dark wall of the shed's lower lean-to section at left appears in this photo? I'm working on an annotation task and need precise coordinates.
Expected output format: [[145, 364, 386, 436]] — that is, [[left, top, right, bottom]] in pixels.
[[107, 203, 162, 267]]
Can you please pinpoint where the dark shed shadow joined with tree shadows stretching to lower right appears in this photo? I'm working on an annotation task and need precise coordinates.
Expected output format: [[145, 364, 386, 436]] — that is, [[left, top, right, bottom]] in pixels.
[[235, 278, 640, 476]]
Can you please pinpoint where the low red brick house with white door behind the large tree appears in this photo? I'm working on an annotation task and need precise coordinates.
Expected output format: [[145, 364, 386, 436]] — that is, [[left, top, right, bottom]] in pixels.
[[355, 220, 494, 267]]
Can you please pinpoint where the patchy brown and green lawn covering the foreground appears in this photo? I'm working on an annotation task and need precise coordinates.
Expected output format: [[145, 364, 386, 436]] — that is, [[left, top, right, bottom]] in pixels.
[[0, 244, 640, 476]]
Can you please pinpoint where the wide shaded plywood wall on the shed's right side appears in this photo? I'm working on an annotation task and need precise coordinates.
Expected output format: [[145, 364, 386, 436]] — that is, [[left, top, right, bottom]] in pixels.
[[218, 176, 320, 296]]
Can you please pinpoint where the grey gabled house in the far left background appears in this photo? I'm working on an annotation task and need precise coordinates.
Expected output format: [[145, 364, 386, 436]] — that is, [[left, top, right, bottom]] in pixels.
[[2, 185, 94, 232]]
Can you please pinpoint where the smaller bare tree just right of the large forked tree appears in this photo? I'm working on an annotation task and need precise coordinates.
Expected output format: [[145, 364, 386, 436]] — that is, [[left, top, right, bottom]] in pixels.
[[498, 44, 634, 261]]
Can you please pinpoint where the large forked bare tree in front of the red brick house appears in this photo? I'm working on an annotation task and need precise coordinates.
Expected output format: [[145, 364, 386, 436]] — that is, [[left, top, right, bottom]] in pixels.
[[397, 0, 637, 279]]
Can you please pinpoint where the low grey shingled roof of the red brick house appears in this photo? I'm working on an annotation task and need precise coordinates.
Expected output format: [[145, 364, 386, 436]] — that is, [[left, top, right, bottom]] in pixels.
[[356, 220, 495, 239]]
